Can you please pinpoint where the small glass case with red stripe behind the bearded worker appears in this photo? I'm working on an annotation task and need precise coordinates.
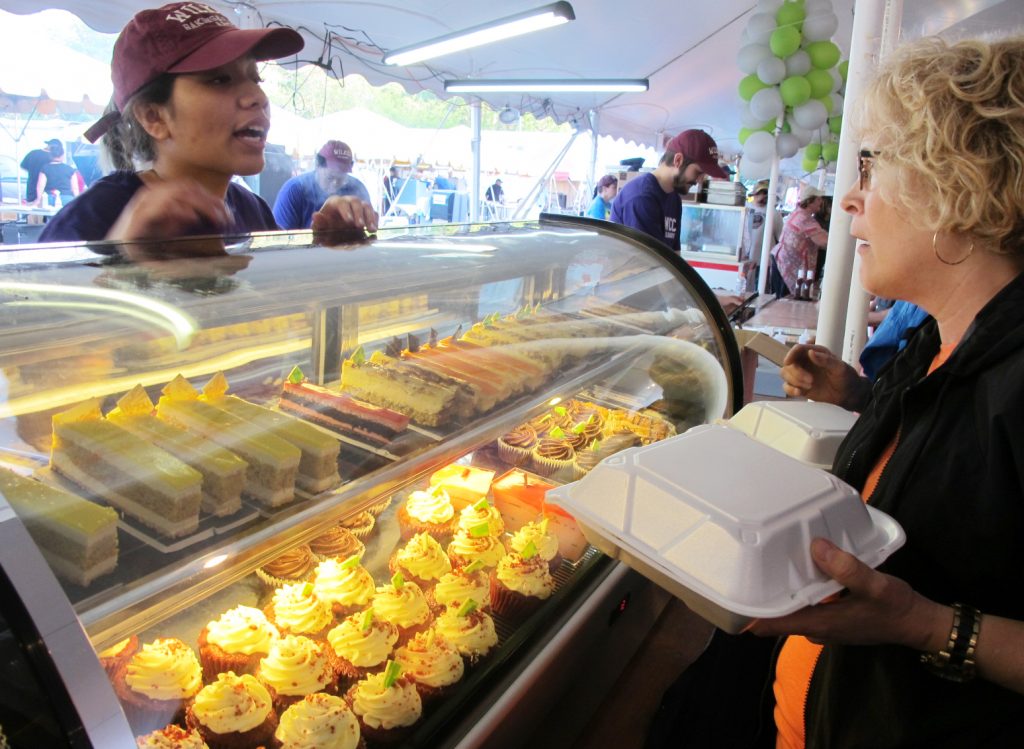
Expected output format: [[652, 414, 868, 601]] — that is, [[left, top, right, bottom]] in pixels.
[[679, 201, 760, 291]]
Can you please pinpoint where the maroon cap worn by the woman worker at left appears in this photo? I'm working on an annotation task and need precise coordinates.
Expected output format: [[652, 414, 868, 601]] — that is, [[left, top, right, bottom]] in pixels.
[[85, 3, 304, 142]]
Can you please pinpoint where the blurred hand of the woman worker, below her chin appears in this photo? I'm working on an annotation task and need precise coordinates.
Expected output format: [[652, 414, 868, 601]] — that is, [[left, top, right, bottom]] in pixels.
[[106, 179, 231, 241]]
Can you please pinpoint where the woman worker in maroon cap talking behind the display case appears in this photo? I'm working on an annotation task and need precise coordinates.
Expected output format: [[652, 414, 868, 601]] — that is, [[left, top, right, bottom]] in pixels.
[[40, 3, 377, 242]]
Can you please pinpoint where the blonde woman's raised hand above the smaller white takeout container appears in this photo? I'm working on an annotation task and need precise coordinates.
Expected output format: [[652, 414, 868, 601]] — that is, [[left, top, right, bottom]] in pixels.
[[779, 343, 871, 411]]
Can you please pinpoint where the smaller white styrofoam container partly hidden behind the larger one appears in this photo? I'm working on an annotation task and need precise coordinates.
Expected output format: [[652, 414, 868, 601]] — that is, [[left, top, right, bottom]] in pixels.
[[726, 401, 857, 469]]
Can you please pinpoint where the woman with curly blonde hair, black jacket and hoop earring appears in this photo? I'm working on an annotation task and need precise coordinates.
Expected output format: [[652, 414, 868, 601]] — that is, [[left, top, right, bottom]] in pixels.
[[754, 37, 1024, 749]]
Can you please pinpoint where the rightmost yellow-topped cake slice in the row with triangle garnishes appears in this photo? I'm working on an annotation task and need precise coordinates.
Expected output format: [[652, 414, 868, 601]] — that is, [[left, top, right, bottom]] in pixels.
[[199, 372, 341, 494]]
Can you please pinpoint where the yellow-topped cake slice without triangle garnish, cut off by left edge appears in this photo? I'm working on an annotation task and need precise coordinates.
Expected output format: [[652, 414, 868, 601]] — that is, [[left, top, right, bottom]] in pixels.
[[0, 468, 118, 585]]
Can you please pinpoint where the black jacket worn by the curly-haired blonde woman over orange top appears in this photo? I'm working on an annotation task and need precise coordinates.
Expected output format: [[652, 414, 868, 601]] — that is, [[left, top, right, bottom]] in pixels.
[[806, 275, 1024, 749]]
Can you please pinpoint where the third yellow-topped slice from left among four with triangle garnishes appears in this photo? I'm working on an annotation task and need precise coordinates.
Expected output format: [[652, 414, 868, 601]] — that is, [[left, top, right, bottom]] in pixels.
[[157, 375, 302, 507]]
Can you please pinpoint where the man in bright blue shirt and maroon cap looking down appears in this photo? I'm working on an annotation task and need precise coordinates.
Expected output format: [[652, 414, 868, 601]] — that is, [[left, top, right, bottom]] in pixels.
[[273, 140, 370, 228]]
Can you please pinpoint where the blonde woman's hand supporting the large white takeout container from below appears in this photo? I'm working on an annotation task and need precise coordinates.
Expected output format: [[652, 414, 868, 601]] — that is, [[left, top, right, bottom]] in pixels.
[[750, 538, 952, 652]]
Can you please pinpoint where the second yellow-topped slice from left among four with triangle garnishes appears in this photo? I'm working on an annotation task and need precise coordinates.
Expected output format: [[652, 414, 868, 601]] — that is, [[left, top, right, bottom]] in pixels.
[[106, 385, 249, 517]]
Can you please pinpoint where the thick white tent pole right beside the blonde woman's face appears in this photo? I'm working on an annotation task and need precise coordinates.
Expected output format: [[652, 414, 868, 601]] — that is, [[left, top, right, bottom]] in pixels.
[[817, 0, 889, 362]]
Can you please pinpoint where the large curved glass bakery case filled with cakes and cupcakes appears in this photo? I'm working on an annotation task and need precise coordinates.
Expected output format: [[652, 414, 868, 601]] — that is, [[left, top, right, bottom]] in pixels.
[[0, 214, 742, 747]]
